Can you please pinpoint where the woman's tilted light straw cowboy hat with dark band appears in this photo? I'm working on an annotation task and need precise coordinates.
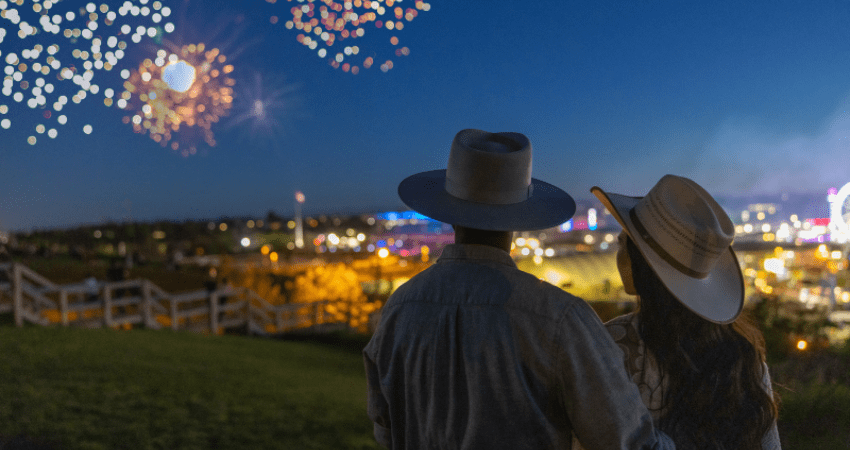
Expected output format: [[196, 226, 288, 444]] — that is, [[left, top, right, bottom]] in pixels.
[[590, 175, 744, 323]]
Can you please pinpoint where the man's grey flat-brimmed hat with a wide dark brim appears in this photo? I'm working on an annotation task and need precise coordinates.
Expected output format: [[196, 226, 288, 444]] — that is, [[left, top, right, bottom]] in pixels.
[[398, 129, 576, 231]]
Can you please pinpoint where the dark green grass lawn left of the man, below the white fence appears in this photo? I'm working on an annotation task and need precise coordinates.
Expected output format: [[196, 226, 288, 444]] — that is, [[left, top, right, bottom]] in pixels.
[[0, 327, 378, 449]]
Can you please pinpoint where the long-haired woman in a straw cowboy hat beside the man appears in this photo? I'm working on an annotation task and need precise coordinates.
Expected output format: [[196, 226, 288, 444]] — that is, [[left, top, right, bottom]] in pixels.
[[591, 175, 780, 449]]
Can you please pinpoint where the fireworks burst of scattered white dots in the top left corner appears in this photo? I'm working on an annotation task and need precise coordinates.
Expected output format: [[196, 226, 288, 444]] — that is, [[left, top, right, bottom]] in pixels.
[[0, 0, 174, 145]]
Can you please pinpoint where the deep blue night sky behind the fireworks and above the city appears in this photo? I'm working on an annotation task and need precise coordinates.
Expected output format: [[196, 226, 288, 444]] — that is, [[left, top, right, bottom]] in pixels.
[[0, 0, 850, 230]]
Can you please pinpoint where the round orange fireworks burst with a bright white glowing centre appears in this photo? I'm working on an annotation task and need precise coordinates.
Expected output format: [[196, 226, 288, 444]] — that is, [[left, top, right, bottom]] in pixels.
[[117, 43, 235, 156]]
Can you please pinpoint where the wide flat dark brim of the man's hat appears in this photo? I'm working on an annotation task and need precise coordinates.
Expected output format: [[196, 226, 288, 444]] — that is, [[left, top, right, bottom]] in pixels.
[[398, 169, 576, 231]]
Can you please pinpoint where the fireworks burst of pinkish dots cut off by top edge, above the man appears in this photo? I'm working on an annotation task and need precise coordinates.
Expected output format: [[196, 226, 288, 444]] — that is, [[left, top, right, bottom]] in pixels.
[[266, 0, 431, 75]]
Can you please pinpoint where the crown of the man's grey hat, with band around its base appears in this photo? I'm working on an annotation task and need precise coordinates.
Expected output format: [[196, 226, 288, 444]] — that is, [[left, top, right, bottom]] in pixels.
[[445, 129, 532, 205]]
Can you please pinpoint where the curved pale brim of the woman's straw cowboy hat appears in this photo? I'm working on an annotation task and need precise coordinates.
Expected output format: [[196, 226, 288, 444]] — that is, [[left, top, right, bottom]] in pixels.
[[590, 186, 744, 324]]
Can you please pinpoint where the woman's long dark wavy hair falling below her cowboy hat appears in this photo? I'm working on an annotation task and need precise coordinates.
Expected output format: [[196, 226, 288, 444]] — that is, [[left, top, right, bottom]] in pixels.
[[626, 239, 777, 450]]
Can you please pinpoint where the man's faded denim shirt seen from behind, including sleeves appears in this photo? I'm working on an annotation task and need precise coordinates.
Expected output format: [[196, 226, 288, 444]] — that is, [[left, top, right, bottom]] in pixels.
[[363, 244, 675, 450]]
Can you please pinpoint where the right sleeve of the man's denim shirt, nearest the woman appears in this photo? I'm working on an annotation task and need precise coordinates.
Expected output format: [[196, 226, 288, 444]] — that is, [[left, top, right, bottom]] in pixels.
[[554, 302, 676, 450]]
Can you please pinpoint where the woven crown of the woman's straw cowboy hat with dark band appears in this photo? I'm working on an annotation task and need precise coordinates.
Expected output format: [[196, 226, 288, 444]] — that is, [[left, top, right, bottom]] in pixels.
[[632, 175, 735, 278]]
